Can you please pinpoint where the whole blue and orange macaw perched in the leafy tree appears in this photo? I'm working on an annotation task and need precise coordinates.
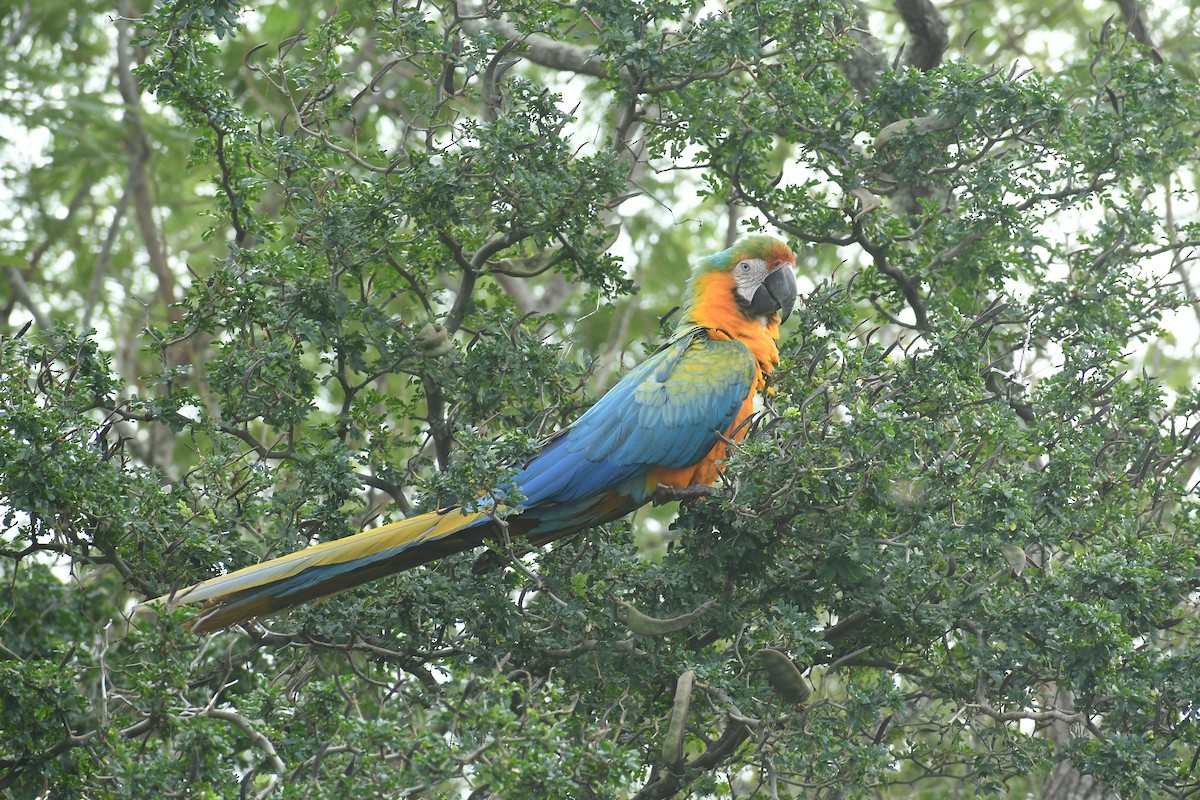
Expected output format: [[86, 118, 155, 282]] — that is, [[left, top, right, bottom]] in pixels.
[[158, 235, 797, 632]]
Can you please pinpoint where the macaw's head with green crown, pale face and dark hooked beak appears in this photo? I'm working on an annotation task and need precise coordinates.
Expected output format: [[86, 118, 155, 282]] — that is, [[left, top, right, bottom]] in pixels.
[[689, 235, 797, 324]]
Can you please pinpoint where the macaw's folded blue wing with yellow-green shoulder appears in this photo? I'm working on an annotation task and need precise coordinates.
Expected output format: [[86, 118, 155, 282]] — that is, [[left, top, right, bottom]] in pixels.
[[515, 329, 755, 509]]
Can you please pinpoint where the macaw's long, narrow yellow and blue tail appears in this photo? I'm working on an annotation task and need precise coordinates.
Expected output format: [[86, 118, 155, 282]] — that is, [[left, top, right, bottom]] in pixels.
[[157, 510, 492, 633]]
